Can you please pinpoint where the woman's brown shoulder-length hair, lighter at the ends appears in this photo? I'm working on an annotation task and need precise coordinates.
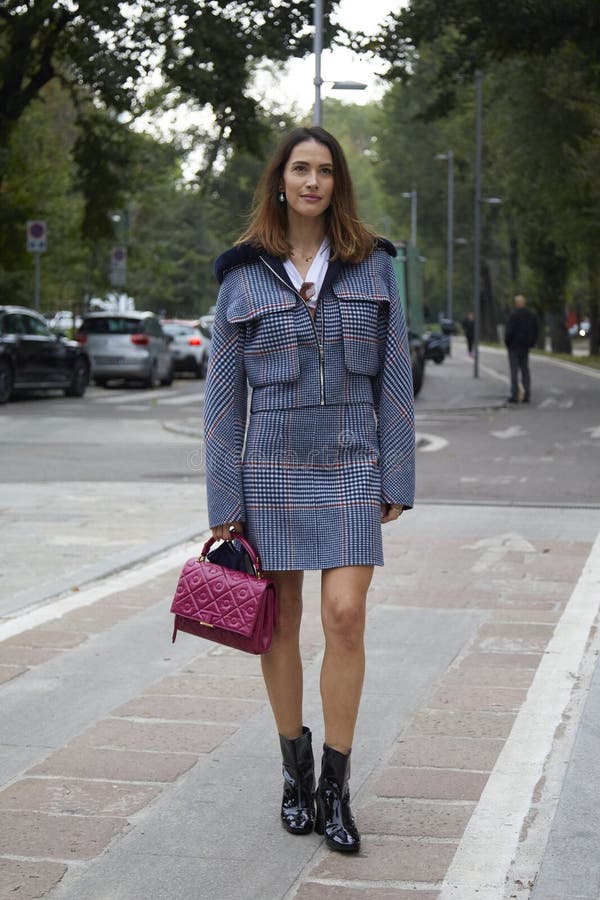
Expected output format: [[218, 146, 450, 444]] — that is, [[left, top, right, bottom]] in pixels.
[[236, 126, 376, 263]]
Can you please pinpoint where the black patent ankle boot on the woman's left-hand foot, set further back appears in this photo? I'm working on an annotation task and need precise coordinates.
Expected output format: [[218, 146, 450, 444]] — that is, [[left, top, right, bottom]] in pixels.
[[279, 727, 315, 834]]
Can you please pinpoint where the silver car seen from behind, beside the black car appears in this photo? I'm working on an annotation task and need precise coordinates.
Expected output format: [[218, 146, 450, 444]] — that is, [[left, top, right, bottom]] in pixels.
[[75, 312, 173, 388]]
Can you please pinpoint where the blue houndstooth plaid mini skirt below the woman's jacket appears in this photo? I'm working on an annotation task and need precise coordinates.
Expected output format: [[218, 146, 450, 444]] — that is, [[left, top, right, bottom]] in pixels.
[[243, 404, 383, 571]]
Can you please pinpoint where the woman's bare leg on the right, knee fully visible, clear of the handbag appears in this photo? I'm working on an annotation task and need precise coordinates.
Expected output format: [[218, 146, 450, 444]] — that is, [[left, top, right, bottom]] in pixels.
[[321, 566, 373, 753]]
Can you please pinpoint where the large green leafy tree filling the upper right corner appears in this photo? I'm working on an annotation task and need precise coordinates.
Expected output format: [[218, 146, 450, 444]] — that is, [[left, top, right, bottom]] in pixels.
[[371, 0, 600, 352]]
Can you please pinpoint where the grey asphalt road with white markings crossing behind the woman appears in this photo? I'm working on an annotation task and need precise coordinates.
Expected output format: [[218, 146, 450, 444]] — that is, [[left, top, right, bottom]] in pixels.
[[0, 339, 600, 505]]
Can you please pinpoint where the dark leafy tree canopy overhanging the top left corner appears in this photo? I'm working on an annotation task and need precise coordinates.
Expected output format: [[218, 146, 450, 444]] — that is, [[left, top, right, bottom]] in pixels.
[[0, 0, 338, 176]]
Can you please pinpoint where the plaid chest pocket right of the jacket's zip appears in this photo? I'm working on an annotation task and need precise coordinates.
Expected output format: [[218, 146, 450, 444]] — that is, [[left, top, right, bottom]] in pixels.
[[339, 297, 380, 375]]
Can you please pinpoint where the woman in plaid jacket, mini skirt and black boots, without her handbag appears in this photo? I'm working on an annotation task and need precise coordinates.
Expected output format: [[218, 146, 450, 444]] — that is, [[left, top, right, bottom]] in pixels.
[[205, 127, 414, 852]]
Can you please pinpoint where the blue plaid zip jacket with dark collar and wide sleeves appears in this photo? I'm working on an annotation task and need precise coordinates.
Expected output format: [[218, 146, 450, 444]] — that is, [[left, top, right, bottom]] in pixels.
[[204, 242, 415, 526]]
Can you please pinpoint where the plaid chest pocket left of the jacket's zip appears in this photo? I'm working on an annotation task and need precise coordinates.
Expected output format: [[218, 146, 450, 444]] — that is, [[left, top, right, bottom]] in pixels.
[[244, 310, 300, 387]]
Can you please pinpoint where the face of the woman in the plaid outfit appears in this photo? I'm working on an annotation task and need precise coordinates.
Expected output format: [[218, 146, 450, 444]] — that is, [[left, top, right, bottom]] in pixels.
[[280, 140, 334, 225]]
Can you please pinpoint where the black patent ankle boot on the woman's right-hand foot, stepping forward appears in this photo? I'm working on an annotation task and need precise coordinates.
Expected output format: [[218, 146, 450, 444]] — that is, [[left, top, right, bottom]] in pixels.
[[315, 744, 360, 853]]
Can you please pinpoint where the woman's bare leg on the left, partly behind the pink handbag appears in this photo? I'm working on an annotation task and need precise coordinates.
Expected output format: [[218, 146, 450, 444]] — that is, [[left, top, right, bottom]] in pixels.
[[261, 572, 304, 740]]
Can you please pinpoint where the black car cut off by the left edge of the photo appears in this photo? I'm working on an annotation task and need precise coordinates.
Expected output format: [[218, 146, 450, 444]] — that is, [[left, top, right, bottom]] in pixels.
[[0, 306, 90, 403]]
